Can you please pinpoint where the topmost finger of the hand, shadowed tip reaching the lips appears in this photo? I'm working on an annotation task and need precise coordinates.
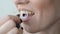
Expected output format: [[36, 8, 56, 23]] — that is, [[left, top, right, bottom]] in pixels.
[[0, 15, 21, 26]]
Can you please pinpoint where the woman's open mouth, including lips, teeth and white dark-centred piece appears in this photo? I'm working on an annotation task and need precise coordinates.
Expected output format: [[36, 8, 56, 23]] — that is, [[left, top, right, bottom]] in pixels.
[[19, 9, 35, 22]]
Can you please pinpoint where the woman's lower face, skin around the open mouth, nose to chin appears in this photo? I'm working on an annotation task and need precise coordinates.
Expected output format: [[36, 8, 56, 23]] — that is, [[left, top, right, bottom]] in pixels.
[[14, 0, 55, 32]]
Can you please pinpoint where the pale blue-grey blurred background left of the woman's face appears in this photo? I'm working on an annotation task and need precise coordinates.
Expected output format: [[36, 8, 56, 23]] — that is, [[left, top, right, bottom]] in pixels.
[[0, 0, 18, 18]]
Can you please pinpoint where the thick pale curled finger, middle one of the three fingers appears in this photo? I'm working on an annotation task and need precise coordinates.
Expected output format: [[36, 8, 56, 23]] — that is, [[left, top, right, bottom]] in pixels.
[[0, 20, 16, 34]]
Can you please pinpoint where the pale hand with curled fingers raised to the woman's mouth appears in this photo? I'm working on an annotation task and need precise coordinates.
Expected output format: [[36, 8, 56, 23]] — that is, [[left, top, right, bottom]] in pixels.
[[0, 15, 20, 34]]
